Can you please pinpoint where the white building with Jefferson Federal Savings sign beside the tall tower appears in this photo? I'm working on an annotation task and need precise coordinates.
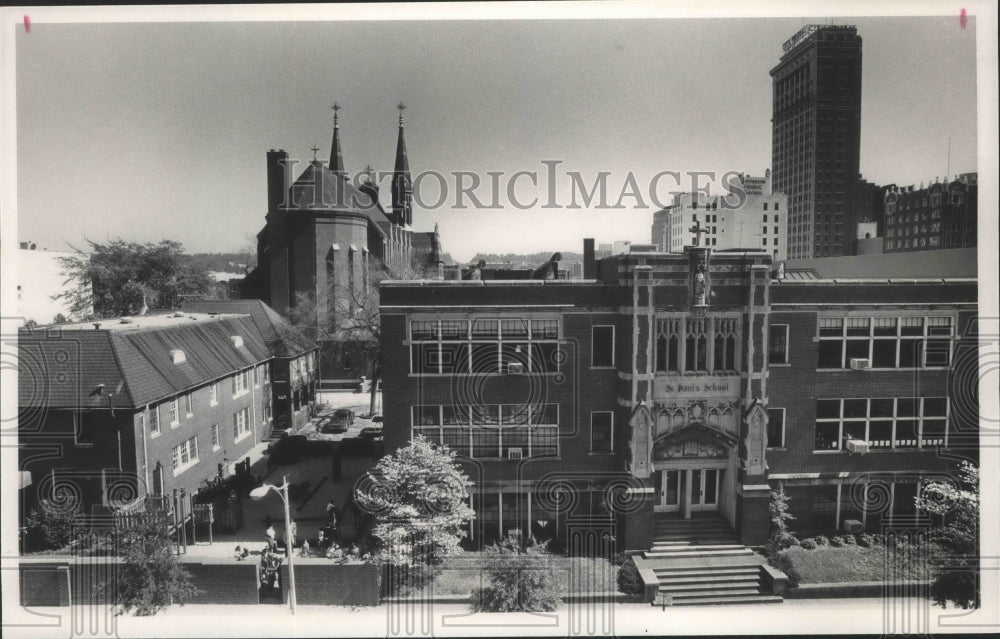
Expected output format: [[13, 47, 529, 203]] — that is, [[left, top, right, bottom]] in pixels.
[[651, 171, 788, 260]]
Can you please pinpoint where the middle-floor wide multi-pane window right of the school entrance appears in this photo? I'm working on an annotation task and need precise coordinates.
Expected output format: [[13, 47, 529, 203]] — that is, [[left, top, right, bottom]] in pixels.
[[814, 397, 948, 450]]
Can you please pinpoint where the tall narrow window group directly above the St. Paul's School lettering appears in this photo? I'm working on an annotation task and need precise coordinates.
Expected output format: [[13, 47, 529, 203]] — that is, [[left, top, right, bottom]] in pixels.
[[654, 315, 740, 373]]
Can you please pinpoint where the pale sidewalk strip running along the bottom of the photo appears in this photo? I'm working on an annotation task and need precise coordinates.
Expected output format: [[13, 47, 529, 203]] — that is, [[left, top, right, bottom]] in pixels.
[[4, 599, 984, 637]]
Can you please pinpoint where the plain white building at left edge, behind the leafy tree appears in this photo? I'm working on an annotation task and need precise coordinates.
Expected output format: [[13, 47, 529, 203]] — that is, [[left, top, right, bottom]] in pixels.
[[17, 242, 94, 324]]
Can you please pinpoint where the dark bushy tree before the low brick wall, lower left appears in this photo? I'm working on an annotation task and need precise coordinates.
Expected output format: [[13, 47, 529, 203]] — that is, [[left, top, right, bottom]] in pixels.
[[105, 516, 199, 616]]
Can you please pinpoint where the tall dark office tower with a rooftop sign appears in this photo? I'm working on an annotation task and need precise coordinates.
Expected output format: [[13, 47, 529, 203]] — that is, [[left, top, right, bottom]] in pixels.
[[771, 24, 861, 259]]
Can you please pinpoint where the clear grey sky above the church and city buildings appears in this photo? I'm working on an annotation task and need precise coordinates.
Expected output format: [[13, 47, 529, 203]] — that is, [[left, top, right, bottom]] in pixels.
[[16, 8, 977, 260]]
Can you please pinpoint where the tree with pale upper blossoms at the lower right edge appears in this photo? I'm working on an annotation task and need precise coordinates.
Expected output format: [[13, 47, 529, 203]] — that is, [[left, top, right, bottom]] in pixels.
[[916, 462, 980, 608]]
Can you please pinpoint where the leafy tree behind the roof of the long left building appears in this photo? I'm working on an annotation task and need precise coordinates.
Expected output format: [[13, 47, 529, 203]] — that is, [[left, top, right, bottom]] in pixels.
[[53, 239, 212, 317]]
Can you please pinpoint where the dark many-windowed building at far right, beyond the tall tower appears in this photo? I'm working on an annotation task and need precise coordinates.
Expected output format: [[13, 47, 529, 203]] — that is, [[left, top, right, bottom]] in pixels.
[[885, 173, 979, 253]]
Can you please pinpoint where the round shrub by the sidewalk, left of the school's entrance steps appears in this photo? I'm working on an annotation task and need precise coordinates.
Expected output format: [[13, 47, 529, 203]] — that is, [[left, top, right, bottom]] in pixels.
[[472, 535, 560, 612]]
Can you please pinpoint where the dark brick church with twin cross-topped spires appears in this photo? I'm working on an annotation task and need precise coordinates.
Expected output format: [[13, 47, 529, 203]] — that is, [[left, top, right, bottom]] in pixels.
[[239, 104, 441, 379]]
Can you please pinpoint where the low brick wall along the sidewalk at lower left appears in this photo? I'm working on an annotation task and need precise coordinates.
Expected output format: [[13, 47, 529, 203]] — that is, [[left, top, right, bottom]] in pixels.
[[19, 556, 379, 607]]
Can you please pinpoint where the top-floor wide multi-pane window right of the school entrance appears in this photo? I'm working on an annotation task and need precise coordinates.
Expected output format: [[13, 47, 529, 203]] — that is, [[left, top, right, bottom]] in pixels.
[[818, 316, 954, 368]]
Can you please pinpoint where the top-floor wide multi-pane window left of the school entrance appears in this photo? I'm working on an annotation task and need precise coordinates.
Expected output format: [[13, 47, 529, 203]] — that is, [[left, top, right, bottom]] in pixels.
[[410, 318, 562, 375]]
